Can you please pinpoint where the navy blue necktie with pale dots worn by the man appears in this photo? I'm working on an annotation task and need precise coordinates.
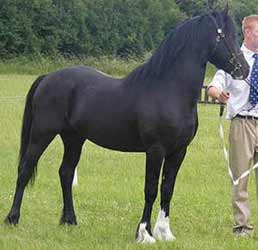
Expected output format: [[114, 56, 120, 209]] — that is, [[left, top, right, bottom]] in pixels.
[[249, 54, 258, 107]]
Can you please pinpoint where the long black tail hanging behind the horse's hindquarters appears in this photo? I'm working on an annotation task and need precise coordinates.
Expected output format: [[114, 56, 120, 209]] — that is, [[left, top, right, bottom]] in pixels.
[[18, 75, 46, 183]]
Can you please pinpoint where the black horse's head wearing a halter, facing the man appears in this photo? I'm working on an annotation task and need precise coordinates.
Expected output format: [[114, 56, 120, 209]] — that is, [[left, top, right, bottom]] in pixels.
[[208, 8, 249, 80]]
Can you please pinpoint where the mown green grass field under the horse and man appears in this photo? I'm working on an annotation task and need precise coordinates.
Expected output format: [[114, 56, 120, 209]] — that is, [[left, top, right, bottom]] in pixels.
[[0, 74, 258, 250]]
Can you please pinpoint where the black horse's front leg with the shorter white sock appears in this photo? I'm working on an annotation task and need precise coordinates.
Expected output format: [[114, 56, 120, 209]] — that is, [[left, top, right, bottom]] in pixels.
[[136, 146, 164, 243]]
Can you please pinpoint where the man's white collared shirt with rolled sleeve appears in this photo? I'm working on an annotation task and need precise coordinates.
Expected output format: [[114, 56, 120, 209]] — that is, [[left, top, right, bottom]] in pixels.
[[209, 45, 258, 119]]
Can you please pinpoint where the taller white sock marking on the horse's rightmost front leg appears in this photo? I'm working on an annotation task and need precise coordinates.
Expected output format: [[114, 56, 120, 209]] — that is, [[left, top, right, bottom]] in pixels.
[[153, 210, 176, 241]]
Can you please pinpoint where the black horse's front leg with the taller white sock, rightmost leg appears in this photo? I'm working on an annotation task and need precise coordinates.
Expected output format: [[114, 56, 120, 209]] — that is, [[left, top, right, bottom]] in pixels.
[[153, 148, 186, 241]]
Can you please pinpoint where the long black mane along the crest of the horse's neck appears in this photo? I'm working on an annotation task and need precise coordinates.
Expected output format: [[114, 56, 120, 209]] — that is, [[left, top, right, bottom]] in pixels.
[[125, 12, 229, 82]]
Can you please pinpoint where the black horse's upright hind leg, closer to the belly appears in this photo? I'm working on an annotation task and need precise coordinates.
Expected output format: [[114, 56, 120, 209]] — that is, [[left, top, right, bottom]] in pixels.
[[59, 133, 85, 225]]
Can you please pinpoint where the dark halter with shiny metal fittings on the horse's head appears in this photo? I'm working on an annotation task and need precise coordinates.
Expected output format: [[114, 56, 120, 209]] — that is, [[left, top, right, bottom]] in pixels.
[[208, 14, 242, 75]]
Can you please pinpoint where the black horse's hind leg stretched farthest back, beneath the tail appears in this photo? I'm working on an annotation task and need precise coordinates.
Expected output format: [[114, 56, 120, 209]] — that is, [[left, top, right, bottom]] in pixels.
[[5, 132, 54, 225]]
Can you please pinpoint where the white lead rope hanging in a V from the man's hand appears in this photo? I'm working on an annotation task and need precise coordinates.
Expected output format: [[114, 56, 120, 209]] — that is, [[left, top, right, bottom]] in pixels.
[[219, 73, 258, 186]]
